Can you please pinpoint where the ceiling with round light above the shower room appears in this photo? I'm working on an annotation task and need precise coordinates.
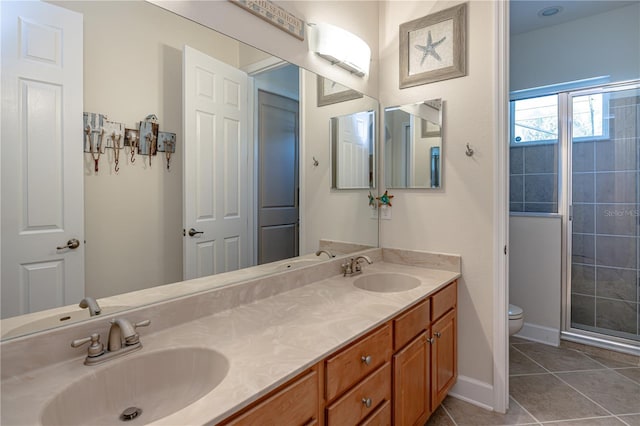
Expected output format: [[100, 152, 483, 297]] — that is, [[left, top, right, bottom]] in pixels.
[[509, 0, 638, 35]]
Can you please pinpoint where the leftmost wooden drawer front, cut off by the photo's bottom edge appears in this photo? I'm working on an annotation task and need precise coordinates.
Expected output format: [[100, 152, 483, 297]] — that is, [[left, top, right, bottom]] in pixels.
[[225, 369, 319, 426]]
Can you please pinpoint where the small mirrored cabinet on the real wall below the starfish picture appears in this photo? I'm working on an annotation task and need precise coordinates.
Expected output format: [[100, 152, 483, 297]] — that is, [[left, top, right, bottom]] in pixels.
[[384, 99, 443, 188]]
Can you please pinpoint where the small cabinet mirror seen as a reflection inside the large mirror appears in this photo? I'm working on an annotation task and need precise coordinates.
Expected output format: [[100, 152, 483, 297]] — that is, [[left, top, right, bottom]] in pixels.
[[331, 111, 376, 189]]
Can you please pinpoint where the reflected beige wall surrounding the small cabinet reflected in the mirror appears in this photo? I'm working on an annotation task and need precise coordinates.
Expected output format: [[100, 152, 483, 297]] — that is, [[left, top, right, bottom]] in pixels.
[[300, 71, 379, 253]]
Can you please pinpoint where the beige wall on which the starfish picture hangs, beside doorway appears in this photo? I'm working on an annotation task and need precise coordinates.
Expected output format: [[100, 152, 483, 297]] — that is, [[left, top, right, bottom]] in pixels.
[[380, 0, 499, 392]]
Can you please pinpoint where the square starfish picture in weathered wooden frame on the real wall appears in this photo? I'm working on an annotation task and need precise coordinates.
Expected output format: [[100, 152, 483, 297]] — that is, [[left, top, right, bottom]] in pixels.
[[400, 3, 467, 89]]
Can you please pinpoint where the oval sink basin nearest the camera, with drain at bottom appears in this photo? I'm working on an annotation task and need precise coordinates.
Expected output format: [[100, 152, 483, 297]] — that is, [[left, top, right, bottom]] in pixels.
[[41, 347, 229, 426]]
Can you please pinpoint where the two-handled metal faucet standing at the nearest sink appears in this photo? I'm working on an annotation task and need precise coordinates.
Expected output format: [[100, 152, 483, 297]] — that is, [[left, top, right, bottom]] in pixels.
[[71, 318, 151, 365]]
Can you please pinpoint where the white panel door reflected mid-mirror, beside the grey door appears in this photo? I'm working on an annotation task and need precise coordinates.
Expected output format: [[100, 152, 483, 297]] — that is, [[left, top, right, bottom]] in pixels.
[[182, 46, 249, 279]]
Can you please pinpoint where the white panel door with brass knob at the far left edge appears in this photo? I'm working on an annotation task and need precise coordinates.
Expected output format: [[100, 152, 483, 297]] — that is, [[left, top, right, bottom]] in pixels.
[[0, 1, 84, 318]]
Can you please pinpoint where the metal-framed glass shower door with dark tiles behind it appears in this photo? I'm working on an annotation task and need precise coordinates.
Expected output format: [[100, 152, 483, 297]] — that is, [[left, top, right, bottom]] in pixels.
[[568, 85, 640, 346]]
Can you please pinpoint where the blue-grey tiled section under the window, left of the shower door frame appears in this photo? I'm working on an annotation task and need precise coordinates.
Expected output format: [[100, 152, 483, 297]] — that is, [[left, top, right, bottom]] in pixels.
[[509, 143, 558, 213]]
